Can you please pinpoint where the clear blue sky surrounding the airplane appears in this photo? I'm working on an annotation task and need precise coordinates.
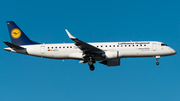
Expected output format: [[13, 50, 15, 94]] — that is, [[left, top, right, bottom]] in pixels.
[[0, 0, 180, 101]]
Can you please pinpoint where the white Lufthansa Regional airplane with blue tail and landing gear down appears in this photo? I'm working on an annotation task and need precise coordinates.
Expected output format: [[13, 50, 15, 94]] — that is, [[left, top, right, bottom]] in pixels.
[[3, 21, 177, 71]]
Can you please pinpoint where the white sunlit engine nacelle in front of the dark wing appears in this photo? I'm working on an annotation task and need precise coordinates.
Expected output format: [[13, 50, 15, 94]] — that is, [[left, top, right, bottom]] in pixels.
[[105, 51, 119, 59]]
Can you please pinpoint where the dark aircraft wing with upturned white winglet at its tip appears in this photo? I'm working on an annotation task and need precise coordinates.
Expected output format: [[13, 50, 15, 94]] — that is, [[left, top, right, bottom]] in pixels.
[[65, 29, 104, 53]]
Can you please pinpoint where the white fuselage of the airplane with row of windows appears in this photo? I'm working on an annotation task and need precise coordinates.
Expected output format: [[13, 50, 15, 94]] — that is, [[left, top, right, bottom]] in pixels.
[[5, 41, 176, 61]]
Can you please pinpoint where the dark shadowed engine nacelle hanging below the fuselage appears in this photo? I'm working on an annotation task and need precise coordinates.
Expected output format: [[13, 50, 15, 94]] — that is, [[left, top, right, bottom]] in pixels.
[[100, 59, 120, 66]]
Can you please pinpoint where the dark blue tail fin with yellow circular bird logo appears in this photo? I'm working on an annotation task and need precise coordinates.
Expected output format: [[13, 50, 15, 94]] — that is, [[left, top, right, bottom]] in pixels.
[[7, 21, 39, 45]]
